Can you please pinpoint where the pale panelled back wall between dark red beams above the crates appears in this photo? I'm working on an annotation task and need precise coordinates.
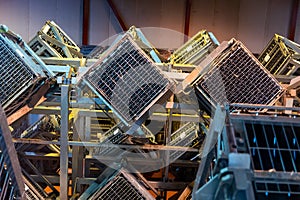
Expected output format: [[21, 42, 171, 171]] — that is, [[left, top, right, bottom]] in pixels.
[[0, 0, 300, 53]]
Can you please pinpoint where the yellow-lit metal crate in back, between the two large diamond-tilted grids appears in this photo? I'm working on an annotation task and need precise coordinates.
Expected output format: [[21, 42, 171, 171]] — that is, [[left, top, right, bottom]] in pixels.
[[171, 30, 219, 65]]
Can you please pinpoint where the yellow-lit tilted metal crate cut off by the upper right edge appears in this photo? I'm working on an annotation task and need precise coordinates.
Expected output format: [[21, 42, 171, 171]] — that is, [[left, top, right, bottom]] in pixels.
[[258, 34, 300, 75]]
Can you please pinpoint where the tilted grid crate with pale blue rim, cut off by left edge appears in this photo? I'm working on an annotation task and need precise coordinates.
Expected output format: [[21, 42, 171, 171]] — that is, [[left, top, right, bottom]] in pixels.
[[0, 34, 46, 109]]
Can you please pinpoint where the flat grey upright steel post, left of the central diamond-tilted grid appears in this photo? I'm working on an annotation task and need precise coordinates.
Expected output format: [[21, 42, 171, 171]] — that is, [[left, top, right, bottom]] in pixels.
[[59, 84, 69, 200]]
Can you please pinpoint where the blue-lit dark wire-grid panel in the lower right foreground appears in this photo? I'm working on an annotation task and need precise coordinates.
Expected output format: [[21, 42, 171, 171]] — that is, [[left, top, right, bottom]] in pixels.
[[232, 116, 300, 199]]
